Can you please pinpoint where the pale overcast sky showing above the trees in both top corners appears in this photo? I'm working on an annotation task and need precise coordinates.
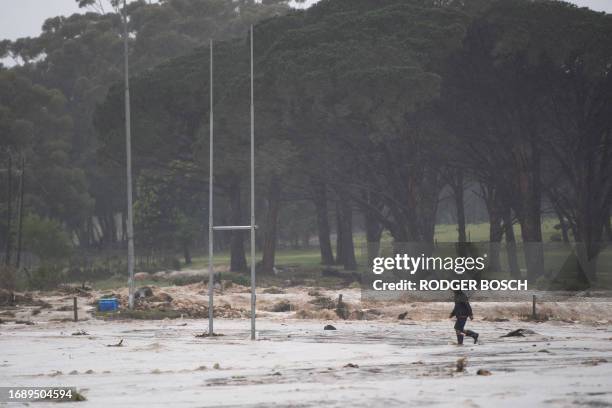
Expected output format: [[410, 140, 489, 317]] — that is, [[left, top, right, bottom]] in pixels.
[[0, 0, 612, 40]]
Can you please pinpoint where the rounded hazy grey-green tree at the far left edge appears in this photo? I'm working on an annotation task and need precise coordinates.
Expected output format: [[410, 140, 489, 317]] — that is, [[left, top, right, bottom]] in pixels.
[[0, 71, 92, 242]]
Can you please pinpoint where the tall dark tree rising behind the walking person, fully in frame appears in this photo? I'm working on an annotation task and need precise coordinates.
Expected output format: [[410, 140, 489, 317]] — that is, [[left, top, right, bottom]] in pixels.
[[446, 1, 544, 277]]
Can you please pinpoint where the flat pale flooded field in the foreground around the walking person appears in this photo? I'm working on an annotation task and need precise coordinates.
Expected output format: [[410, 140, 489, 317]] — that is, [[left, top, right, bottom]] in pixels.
[[0, 316, 612, 407]]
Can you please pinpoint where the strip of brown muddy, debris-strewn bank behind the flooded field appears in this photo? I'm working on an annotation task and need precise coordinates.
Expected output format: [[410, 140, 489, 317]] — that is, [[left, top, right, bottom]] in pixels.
[[0, 283, 612, 325]]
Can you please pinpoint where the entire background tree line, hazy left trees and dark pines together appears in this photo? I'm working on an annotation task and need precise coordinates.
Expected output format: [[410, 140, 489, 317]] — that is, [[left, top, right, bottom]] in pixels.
[[1, 0, 612, 281]]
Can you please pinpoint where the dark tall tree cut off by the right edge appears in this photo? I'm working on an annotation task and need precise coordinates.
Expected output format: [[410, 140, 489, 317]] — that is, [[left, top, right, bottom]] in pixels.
[[540, 6, 612, 284]]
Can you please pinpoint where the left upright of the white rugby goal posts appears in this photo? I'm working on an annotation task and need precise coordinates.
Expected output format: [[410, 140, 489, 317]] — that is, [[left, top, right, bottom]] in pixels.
[[208, 40, 214, 336]]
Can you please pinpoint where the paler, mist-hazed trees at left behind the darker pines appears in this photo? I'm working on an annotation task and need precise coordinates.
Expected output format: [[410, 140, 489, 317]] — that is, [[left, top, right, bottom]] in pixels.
[[0, 0, 296, 270]]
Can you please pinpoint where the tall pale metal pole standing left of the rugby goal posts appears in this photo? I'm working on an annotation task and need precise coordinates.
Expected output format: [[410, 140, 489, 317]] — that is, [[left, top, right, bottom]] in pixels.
[[123, 0, 134, 309]]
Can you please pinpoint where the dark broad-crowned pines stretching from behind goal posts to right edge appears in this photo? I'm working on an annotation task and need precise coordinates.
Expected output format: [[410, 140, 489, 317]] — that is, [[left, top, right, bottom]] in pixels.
[[97, 0, 612, 280]]
